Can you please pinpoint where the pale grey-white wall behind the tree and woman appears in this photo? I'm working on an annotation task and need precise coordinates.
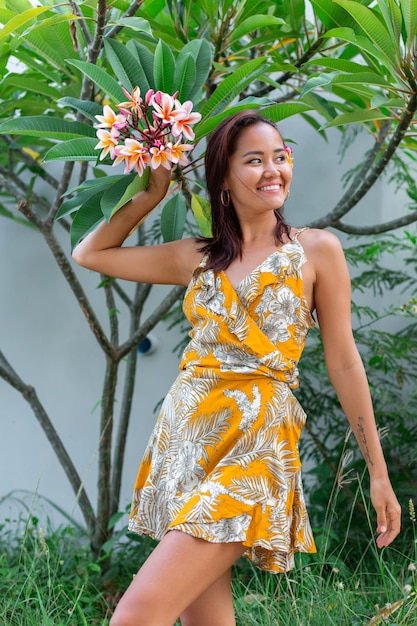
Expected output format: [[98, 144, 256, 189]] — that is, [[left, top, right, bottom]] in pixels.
[[0, 119, 404, 520]]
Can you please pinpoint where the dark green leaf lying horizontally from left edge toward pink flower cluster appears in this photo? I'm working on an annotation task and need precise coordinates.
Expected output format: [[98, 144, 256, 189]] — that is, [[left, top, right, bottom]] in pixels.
[[0, 115, 95, 139]]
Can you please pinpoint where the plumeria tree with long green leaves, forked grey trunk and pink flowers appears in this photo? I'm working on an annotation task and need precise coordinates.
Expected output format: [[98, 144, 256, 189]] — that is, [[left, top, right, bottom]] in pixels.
[[0, 0, 417, 553]]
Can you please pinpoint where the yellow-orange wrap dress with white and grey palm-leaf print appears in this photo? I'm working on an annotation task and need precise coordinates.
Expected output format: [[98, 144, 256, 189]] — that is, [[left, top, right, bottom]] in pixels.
[[129, 231, 315, 572]]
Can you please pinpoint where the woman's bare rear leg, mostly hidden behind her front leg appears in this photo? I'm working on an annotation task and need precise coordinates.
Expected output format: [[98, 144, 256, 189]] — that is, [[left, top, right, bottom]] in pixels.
[[180, 569, 236, 626]]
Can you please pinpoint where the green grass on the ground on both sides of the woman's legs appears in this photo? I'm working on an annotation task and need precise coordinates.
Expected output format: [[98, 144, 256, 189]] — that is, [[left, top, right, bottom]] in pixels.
[[0, 492, 417, 626]]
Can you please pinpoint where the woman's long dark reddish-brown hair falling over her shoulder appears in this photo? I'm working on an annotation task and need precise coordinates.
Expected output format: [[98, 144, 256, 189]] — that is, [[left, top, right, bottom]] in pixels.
[[199, 110, 291, 271]]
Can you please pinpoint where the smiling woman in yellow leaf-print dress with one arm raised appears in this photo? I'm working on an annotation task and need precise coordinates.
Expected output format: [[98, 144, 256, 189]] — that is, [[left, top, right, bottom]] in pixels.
[[74, 111, 400, 626]]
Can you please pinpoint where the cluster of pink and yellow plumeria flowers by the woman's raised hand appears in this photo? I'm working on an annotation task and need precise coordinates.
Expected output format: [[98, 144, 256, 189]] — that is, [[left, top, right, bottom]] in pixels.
[[95, 87, 201, 176]]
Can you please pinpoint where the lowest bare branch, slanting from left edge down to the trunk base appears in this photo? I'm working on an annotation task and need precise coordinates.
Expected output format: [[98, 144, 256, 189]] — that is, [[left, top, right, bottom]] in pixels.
[[0, 351, 96, 532]]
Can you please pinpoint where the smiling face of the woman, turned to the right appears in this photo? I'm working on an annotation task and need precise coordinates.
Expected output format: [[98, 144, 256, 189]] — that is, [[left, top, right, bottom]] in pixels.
[[222, 122, 292, 217]]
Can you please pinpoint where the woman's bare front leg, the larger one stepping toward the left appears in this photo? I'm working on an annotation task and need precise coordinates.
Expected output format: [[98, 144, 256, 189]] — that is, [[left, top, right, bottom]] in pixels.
[[110, 530, 245, 626]]
